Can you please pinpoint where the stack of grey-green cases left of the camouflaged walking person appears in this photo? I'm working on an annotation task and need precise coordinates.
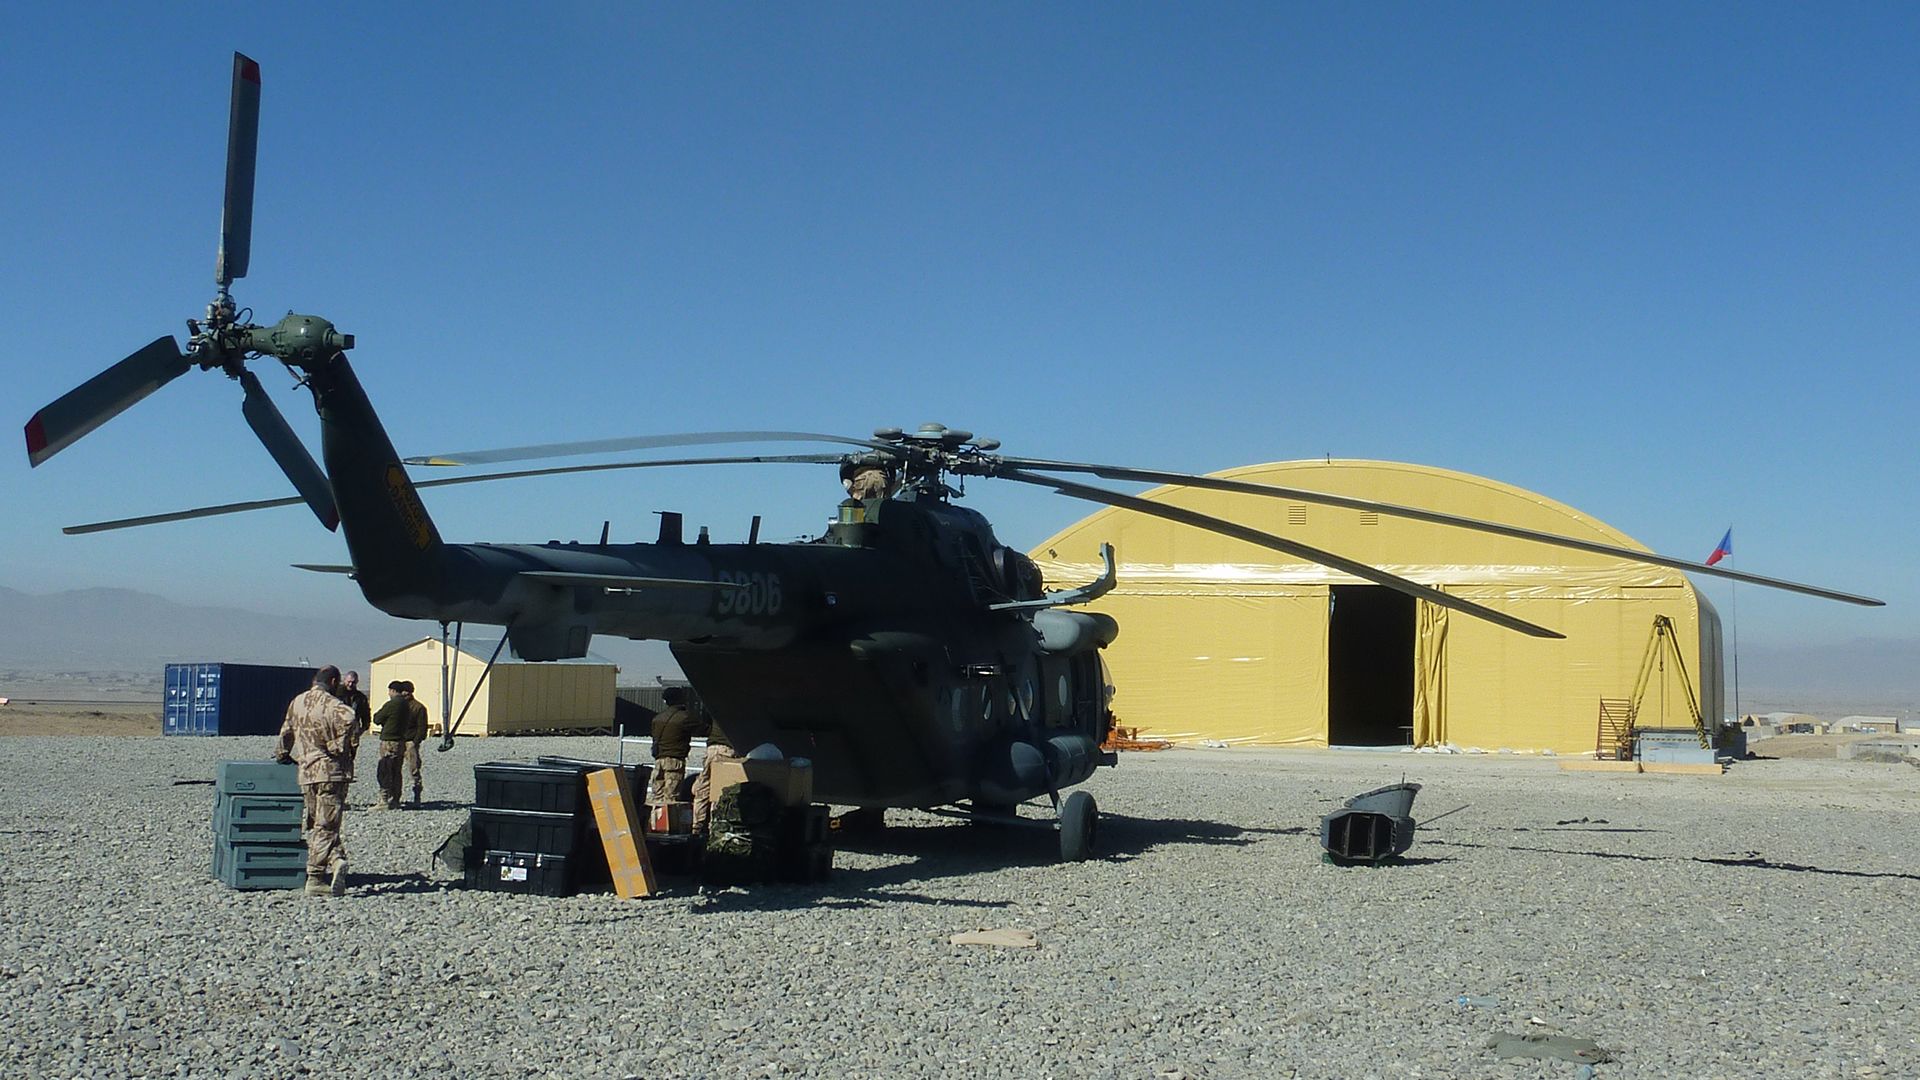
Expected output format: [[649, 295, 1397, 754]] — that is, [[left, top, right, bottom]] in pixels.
[[213, 761, 307, 890]]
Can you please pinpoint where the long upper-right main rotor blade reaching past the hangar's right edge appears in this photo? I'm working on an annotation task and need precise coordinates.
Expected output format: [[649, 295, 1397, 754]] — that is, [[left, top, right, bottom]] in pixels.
[[1002, 457, 1885, 607]]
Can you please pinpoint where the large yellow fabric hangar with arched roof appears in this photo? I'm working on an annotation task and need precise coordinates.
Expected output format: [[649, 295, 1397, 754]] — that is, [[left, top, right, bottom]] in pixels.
[[1033, 459, 1722, 753]]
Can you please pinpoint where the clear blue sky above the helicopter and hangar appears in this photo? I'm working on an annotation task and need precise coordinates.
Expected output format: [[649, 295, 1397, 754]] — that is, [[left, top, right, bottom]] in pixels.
[[0, 4, 1920, 644]]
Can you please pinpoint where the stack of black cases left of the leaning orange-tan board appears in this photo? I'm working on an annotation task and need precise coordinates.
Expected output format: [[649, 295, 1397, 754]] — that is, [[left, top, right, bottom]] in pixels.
[[467, 761, 607, 896]]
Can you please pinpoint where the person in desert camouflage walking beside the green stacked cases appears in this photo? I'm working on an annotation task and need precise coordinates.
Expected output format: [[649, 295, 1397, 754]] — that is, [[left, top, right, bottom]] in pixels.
[[280, 665, 359, 896]]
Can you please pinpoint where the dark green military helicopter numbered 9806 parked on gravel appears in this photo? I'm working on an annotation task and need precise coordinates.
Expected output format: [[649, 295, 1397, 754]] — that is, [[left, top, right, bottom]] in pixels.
[[25, 54, 1880, 859]]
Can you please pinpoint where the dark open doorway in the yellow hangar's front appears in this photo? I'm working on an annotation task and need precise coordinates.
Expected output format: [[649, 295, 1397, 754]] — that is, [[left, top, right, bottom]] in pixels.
[[1327, 584, 1415, 746]]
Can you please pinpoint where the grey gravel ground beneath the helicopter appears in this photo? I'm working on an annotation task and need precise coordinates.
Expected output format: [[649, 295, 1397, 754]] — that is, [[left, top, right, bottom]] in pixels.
[[0, 736, 1920, 1078]]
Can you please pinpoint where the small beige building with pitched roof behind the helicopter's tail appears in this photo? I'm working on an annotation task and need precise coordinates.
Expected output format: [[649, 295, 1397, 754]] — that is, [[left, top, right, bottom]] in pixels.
[[367, 638, 620, 736]]
